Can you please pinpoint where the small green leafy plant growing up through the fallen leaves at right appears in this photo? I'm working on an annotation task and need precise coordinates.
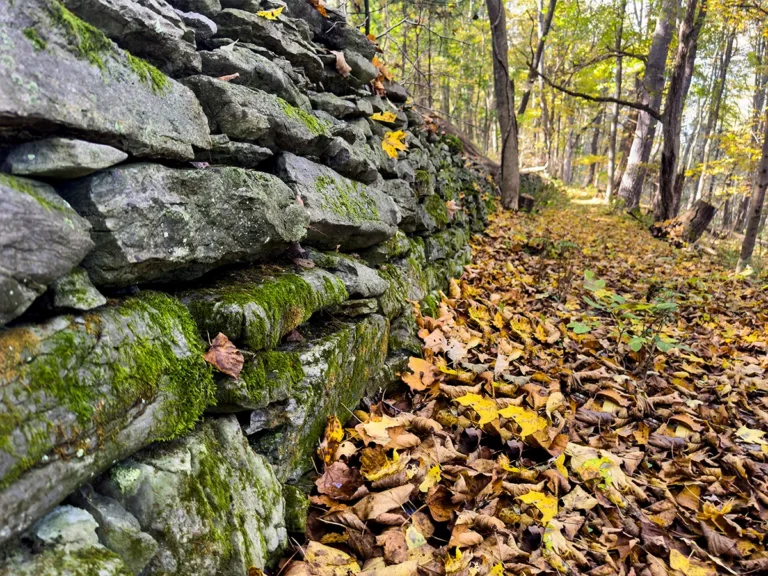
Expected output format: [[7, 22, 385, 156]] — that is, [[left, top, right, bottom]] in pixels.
[[580, 270, 681, 370]]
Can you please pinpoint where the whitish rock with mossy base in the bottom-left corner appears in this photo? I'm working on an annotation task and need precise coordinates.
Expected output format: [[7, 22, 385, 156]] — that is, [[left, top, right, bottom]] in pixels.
[[0, 506, 132, 576]]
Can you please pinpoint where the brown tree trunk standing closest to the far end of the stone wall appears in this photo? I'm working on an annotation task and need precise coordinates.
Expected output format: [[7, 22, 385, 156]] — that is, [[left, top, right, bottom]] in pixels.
[[486, 0, 520, 210]]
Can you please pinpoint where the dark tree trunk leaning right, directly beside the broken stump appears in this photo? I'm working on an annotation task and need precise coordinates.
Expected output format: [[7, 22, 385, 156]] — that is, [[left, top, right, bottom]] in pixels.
[[654, 0, 707, 222]]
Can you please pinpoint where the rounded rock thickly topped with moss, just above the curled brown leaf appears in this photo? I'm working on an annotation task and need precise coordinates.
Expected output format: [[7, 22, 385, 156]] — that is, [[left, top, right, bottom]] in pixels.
[[179, 267, 348, 351]]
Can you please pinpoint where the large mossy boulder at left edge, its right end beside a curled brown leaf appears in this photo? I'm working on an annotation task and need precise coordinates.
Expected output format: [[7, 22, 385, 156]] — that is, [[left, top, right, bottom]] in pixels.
[[0, 292, 214, 542]]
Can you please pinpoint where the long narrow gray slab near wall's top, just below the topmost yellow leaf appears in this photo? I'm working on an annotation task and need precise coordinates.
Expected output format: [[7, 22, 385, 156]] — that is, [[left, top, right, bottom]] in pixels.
[[216, 8, 323, 82]]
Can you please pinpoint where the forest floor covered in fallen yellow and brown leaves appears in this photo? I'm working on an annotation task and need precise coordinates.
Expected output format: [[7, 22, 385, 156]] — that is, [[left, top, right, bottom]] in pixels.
[[281, 192, 768, 576]]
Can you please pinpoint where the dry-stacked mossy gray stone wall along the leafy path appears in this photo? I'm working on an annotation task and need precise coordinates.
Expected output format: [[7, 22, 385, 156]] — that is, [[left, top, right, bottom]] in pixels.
[[0, 0, 492, 576]]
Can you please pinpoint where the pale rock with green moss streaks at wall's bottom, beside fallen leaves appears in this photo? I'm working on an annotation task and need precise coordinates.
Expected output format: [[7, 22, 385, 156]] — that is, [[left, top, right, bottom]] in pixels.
[[97, 416, 287, 576]]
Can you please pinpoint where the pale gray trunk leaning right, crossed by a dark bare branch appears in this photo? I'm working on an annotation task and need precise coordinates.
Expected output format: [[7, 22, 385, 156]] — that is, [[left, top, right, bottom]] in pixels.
[[619, 0, 679, 210]]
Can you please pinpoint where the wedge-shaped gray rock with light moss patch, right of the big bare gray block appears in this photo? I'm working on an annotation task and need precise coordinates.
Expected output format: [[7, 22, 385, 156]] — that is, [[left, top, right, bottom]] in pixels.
[[278, 153, 400, 250]]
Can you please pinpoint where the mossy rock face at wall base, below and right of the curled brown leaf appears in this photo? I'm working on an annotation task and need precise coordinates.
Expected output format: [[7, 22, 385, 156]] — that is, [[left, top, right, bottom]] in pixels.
[[246, 314, 389, 481]]
